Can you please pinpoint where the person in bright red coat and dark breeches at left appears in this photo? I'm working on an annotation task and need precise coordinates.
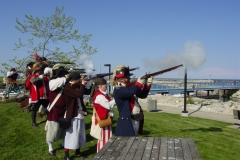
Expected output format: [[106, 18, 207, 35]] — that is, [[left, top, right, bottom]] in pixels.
[[25, 63, 49, 127]]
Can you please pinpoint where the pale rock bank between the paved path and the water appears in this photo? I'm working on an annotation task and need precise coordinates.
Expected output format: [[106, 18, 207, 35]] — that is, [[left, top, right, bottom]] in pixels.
[[138, 91, 240, 115]]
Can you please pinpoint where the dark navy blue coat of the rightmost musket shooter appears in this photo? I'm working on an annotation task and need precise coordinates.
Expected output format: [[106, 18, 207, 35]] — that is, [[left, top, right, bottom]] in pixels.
[[114, 85, 150, 136]]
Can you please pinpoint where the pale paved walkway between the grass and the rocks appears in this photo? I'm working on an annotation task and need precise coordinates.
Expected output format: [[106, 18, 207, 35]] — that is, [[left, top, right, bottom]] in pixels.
[[140, 103, 240, 127]]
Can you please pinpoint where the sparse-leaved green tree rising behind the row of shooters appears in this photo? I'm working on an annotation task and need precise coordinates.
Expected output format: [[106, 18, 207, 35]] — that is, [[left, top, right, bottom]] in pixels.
[[0, 7, 97, 74]]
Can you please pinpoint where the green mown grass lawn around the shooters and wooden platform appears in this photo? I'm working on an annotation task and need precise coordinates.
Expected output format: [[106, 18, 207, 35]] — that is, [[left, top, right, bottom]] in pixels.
[[0, 103, 240, 160]]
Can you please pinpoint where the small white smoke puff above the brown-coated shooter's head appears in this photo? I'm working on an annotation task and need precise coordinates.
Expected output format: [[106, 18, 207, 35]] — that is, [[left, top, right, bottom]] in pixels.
[[79, 53, 94, 75]]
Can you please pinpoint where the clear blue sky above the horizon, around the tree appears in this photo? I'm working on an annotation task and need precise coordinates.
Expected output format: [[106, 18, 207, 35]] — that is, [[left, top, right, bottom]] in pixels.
[[0, 0, 240, 79]]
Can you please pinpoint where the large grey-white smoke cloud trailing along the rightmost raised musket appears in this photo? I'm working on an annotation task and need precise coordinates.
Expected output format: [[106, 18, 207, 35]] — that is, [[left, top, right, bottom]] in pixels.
[[143, 41, 206, 73]]
